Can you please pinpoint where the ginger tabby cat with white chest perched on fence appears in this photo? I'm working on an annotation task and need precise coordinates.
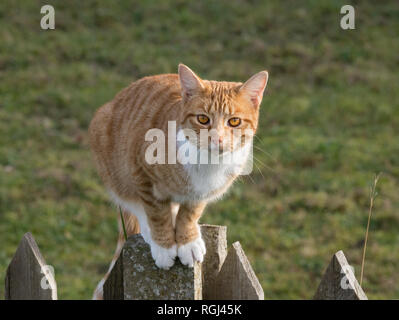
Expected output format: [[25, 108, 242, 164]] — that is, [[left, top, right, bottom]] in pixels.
[[89, 64, 268, 298]]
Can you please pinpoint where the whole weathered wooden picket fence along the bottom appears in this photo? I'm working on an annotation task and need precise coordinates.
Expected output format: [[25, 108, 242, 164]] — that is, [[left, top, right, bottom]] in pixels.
[[5, 225, 367, 300]]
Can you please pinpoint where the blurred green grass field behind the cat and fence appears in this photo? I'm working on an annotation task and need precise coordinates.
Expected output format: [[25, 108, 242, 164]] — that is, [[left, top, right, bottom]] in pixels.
[[0, 0, 399, 299]]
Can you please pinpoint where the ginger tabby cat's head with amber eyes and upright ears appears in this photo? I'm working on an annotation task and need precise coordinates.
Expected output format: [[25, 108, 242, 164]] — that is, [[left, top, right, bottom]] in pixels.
[[179, 64, 268, 153]]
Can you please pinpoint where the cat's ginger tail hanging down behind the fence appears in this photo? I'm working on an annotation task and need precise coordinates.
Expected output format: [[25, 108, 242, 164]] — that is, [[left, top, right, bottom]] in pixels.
[[93, 211, 140, 300]]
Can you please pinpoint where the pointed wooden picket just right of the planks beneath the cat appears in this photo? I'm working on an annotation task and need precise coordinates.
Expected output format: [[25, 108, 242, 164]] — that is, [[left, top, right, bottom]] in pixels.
[[216, 242, 264, 300]]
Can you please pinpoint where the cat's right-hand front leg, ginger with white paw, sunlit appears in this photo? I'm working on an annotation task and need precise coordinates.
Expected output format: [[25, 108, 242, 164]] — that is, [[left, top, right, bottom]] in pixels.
[[176, 202, 206, 267]]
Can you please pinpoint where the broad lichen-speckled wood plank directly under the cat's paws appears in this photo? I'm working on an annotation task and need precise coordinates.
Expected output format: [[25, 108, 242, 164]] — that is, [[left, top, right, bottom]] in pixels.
[[104, 234, 202, 300]]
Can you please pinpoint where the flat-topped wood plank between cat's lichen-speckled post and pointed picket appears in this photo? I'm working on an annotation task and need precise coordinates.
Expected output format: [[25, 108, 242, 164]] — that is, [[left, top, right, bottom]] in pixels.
[[201, 224, 227, 300]]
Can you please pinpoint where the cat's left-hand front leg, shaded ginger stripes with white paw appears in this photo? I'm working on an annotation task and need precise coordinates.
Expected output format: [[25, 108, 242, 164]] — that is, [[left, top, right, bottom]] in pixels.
[[144, 199, 177, 270]]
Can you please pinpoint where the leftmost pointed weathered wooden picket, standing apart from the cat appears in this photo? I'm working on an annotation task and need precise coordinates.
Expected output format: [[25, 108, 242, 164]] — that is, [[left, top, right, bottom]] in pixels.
[[5, 233, 57, 300]]
